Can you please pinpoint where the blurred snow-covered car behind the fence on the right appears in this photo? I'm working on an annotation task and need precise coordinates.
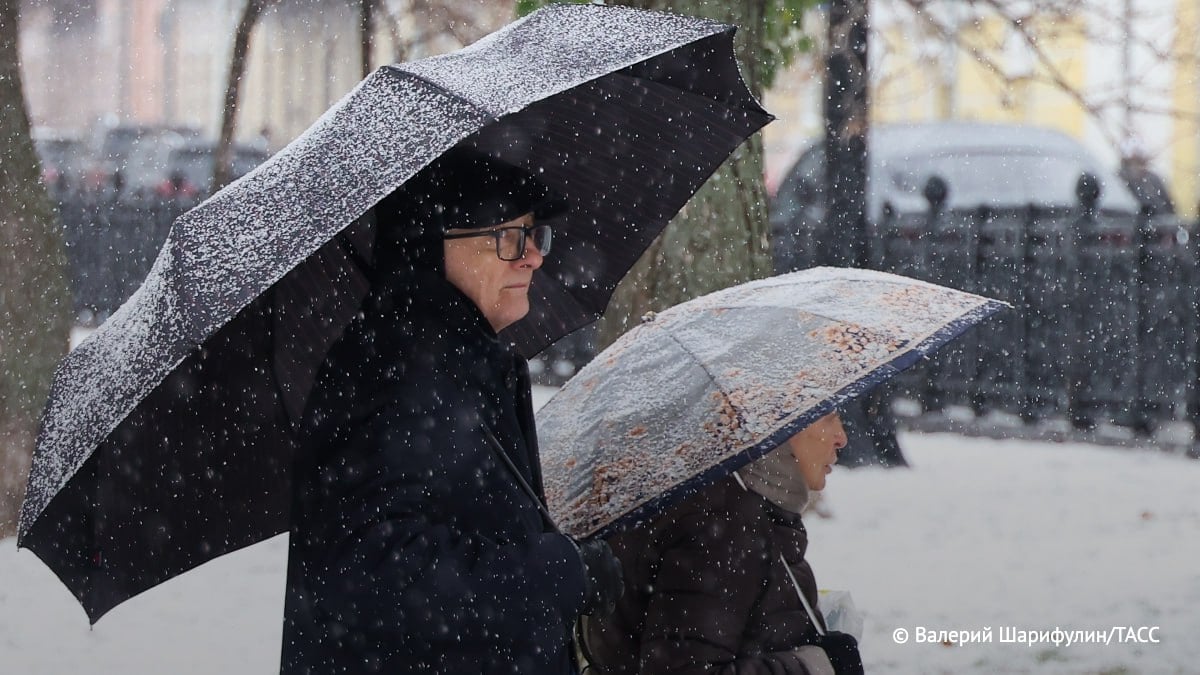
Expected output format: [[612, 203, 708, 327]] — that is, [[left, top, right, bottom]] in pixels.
[[770, 121, 1139, 268]]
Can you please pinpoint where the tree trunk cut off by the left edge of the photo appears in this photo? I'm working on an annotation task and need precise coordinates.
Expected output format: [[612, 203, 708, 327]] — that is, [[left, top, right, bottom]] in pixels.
[[0, 0, 71, 537]]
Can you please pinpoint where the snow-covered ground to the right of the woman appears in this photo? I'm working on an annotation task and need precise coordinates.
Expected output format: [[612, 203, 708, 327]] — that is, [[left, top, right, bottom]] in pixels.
[[808, 435, 1200, 675]]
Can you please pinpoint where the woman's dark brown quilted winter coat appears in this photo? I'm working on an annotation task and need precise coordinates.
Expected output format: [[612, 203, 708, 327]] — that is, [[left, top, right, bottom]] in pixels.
[[587, 478, 823, 675]]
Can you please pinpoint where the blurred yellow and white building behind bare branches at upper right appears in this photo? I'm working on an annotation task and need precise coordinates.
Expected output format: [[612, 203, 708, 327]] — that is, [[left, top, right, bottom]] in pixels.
[[766, 0, 1200, 215]]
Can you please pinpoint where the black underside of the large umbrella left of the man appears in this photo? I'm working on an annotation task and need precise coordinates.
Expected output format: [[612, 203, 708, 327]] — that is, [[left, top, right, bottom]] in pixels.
[[23, 208, 374, 616]]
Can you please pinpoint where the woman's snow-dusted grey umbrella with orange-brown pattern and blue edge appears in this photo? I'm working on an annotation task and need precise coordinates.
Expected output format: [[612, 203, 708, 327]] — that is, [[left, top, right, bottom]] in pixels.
[[538, 268, 1004, 538]]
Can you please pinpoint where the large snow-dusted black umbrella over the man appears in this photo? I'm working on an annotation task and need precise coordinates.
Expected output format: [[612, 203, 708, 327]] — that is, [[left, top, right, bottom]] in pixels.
[[18, 5, 770, 621]]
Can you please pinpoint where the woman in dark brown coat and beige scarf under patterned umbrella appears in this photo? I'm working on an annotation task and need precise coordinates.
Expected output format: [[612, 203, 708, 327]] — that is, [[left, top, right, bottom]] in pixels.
[[587, 413, 863, 675]]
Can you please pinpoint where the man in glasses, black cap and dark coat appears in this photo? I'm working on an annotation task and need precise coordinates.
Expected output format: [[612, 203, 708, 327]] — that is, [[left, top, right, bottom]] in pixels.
[[282, 150, 622, 674]]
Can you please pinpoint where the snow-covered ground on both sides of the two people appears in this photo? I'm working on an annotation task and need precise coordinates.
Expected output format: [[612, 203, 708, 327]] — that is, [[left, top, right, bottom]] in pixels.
[[0, 381, 1200, 675]]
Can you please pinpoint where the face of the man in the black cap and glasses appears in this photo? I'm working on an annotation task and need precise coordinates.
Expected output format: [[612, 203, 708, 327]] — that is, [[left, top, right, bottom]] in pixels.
[[443, 214, 542, 333]]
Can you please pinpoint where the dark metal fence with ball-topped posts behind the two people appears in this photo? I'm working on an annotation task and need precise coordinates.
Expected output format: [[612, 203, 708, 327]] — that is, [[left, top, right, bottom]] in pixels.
[[60, 194, 1200, 434]]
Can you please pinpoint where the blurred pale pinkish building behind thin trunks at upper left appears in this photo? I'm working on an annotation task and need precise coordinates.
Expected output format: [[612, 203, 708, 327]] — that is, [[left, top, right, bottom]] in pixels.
[[20, 0, 514, 150]]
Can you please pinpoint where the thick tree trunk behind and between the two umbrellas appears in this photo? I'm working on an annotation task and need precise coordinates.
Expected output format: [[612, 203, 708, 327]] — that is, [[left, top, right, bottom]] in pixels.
[[598, 0, 772, 348]]
